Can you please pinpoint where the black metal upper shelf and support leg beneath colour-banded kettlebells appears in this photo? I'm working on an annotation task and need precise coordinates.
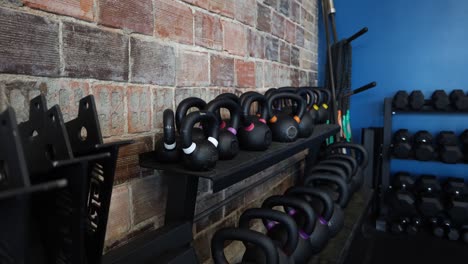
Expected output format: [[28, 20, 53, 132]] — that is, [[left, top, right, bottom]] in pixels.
[[100, 125, 339, 264]]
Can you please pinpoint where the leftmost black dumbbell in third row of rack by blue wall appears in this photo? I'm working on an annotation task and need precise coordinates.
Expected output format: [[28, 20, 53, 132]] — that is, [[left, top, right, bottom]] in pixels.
[[387, 172, 417, 218]]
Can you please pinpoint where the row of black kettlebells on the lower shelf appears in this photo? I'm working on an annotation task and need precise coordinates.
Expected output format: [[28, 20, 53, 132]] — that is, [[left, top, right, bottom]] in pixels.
[[211, 142, 368, 264]]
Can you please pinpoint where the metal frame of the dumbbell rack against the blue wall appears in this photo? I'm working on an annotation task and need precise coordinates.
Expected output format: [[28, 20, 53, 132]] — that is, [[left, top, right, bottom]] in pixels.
[[376, 98, 468, 231]]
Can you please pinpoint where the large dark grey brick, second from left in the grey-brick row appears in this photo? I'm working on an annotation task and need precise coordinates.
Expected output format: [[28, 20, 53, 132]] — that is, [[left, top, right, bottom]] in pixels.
[[63, 22, 128, 81]]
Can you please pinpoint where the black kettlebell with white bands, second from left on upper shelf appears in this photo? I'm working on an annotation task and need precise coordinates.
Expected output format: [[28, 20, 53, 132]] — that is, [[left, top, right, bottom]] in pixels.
[[180, 111, 219, 171]]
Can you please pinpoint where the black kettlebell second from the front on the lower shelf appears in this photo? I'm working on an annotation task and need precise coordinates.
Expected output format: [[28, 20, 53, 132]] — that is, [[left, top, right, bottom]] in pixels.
[[239, 208, 299, 264]]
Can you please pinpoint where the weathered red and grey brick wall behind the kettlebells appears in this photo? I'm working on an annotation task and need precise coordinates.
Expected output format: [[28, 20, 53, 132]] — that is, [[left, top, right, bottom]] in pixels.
[[0, 0, 318, 261]]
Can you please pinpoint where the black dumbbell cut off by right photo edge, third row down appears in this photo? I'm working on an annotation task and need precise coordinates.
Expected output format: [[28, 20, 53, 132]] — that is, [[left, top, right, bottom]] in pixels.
[[444, 178, 468, 226]]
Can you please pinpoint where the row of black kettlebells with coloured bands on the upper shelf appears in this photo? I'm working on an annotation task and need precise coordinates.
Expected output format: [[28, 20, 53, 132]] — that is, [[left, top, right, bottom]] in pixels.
[[156, 87, 331, 171]]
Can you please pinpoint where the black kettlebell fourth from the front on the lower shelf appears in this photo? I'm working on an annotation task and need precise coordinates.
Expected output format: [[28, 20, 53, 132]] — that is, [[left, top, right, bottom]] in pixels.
[[284, 186, 344, 237]]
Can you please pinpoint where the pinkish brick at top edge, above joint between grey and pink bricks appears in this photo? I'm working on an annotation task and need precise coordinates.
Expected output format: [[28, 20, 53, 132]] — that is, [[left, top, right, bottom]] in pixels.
[[155, 0, 193, 44]]
